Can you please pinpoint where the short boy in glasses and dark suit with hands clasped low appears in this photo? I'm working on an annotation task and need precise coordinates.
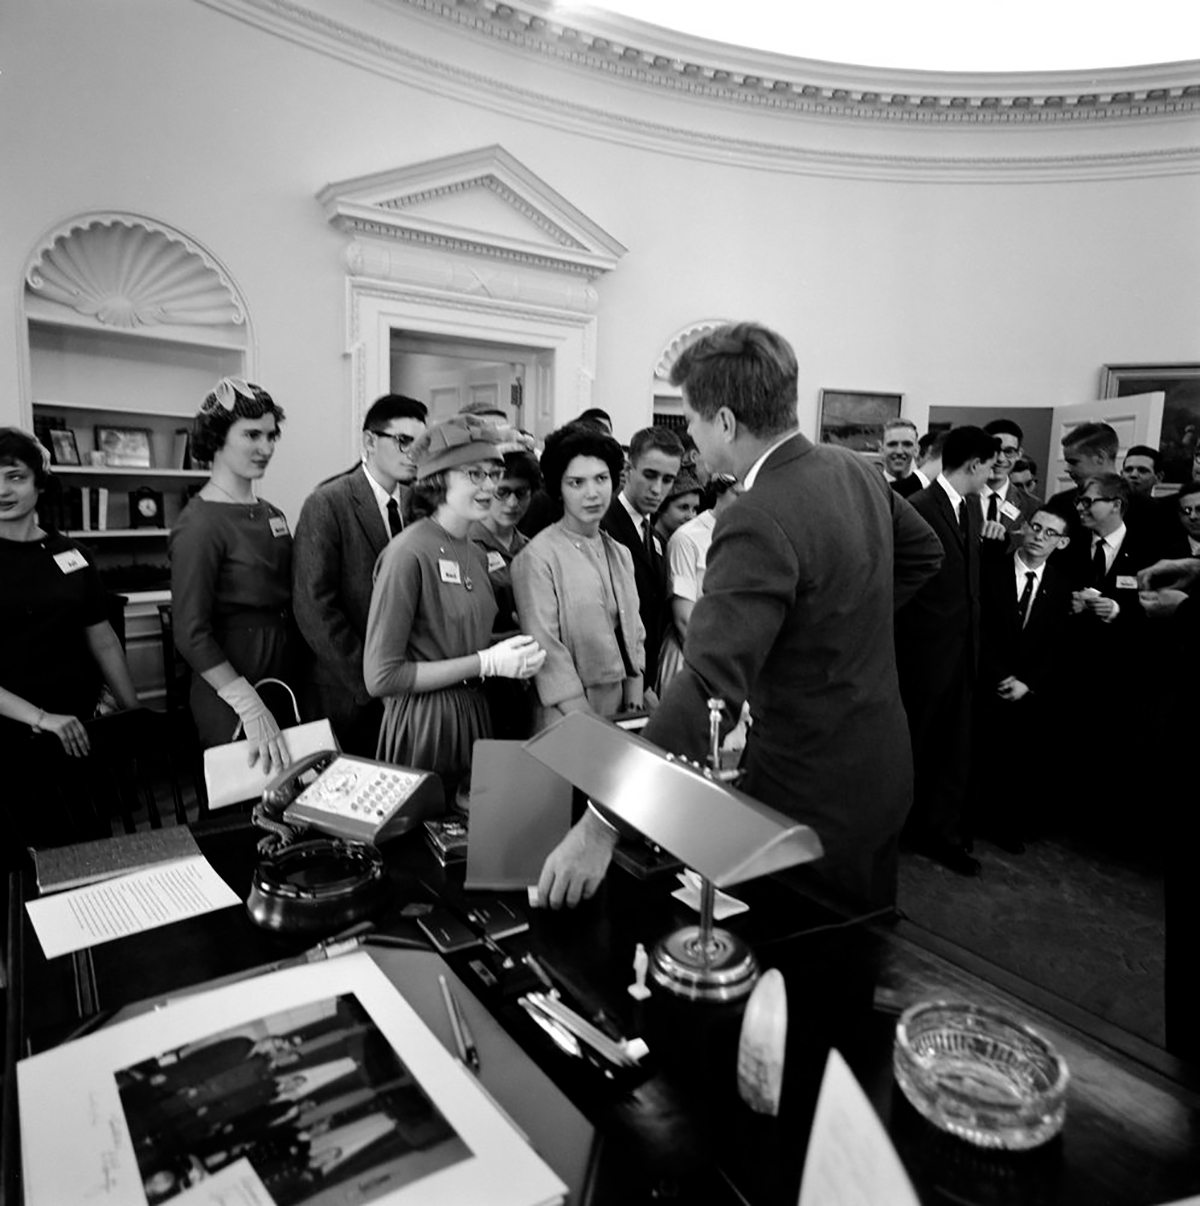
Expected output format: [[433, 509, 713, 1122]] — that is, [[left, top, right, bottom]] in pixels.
[[971, 508, 1071, 854]]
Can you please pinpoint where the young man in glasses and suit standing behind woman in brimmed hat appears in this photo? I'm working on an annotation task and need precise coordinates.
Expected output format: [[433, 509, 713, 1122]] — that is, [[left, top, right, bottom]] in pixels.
[[292, 394, 426, 757]]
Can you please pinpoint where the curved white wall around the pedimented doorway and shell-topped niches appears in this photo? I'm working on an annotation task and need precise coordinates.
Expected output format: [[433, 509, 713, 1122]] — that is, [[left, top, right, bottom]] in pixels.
[[0, 0, 1200, 516]]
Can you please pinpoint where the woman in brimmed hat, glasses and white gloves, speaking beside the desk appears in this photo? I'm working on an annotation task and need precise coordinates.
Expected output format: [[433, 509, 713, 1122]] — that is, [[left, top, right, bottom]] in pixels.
[[363, 415, 545, 802]]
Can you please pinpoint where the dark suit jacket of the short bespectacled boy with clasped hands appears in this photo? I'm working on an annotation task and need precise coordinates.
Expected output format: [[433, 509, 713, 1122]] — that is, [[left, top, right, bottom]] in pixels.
[[979, 554, 1071, 697]]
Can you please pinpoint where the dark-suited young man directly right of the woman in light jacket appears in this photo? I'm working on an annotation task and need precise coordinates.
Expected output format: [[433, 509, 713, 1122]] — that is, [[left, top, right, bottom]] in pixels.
[[601, 427, 684, 683]]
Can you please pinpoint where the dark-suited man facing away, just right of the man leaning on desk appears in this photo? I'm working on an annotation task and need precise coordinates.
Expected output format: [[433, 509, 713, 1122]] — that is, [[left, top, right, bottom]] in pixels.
[[896, 427, 996, 876]]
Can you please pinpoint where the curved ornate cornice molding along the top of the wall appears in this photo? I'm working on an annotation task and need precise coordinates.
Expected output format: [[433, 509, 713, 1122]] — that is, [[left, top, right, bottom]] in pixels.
[[192, 0, 1200, 183]]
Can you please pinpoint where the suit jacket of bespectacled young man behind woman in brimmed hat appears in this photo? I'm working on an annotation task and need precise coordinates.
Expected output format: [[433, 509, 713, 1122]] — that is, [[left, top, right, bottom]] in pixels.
[[292, 464, 408, 706]]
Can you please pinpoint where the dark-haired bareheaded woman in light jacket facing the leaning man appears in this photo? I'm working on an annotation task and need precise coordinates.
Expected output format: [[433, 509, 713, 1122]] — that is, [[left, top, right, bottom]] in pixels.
[[513, 423, 645, 728]]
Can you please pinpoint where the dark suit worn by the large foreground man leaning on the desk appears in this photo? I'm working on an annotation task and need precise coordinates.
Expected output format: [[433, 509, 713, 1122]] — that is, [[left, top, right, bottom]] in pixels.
[[644, 433, 941, 896]]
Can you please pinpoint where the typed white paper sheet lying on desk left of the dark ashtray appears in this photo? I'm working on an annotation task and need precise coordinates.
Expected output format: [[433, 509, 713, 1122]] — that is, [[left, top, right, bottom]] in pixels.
[[25, 855, 241, 959]]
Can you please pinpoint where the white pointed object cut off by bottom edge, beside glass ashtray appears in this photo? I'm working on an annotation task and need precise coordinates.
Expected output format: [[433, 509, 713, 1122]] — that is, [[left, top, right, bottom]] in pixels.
[[800, 1049, 920, 1206]]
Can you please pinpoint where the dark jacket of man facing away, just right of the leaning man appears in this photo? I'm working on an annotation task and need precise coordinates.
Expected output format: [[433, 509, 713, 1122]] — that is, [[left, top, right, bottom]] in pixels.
[[896, 481, 984, 698]]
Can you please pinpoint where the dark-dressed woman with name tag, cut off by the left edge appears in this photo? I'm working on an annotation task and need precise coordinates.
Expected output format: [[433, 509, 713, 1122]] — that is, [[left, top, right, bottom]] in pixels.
[[0, 427, 137, 850]]
